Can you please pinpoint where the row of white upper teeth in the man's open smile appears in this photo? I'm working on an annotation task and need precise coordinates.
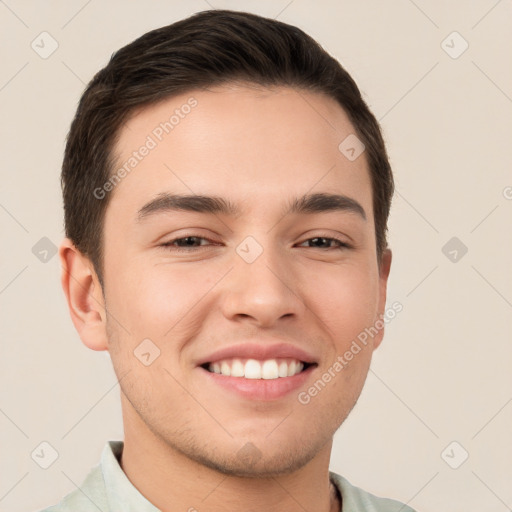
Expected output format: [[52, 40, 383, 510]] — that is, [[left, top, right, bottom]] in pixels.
[[208, 358, 304, 379]]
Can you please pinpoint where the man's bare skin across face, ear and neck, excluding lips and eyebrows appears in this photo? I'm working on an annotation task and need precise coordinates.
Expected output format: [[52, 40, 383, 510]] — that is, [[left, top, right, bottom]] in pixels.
[[60, 84, 391, 512]]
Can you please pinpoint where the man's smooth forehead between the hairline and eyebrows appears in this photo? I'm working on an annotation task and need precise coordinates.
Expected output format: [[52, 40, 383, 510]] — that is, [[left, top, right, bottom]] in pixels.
[[107, 84, 372, 218]]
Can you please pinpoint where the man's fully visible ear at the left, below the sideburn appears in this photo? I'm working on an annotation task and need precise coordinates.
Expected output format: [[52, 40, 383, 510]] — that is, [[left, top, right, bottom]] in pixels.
[[59, 238, 108, 350]]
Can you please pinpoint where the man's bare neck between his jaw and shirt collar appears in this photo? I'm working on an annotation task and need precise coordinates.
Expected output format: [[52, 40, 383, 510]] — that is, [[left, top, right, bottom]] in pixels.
[[121, 400, 340, 512]]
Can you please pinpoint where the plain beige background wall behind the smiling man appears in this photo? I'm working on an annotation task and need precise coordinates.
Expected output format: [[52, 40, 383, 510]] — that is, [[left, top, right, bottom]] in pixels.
[[0, 0, 512, 512]]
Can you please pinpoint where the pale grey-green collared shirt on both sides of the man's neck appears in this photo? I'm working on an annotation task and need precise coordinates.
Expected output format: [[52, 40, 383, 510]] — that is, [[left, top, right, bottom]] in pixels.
[[41, 441, 414, 512]]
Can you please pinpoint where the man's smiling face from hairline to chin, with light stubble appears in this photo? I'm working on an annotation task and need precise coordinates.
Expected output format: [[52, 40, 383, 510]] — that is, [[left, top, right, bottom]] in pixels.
[[99, 85, 390, 476]]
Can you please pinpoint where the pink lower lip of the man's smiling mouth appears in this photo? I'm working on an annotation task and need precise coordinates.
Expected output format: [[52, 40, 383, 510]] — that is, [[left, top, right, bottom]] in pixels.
[[199, 365, 316, 401]]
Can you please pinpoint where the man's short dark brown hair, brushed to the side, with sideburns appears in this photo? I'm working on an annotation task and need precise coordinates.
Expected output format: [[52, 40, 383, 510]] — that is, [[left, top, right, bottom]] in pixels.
[[61, 10, 394, 286]]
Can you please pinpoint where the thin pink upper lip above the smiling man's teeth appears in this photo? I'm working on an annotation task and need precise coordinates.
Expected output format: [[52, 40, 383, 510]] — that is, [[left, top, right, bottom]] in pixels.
[[198, 343, 316, 366]]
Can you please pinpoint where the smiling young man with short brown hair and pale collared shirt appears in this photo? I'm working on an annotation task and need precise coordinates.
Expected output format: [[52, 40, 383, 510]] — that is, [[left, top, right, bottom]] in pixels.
[[42, 10, 411, 512]]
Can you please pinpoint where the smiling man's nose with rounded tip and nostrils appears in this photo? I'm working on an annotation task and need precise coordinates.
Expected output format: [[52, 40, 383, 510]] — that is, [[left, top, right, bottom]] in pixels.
[[222, 244, 305, 327]]
